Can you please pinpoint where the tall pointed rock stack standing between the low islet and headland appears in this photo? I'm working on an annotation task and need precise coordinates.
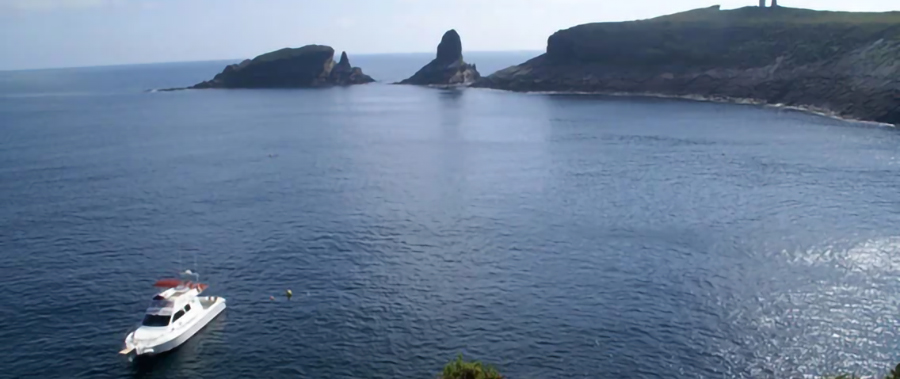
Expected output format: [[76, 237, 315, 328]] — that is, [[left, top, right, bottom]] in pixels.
[[399, 30, 481, 85]]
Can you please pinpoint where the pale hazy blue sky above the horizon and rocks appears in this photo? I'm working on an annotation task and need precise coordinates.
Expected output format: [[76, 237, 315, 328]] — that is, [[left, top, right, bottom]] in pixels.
[[0, 0, 900, 70]]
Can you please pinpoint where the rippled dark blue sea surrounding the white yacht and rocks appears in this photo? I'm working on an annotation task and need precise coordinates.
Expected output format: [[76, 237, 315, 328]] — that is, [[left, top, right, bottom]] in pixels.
[[0, 52, 900, 379]]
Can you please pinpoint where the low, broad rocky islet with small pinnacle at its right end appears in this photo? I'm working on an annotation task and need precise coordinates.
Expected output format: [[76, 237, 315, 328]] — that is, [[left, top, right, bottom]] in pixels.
[[190, 45, 375, 89]]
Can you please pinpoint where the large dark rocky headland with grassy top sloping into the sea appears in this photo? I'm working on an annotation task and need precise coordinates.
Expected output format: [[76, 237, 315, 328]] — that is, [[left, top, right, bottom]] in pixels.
[[476, 6, 900, 124]]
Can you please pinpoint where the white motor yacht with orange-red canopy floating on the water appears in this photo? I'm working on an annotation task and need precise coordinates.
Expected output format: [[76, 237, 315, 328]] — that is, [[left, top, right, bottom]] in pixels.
[[119, 270, 225, 355]]
